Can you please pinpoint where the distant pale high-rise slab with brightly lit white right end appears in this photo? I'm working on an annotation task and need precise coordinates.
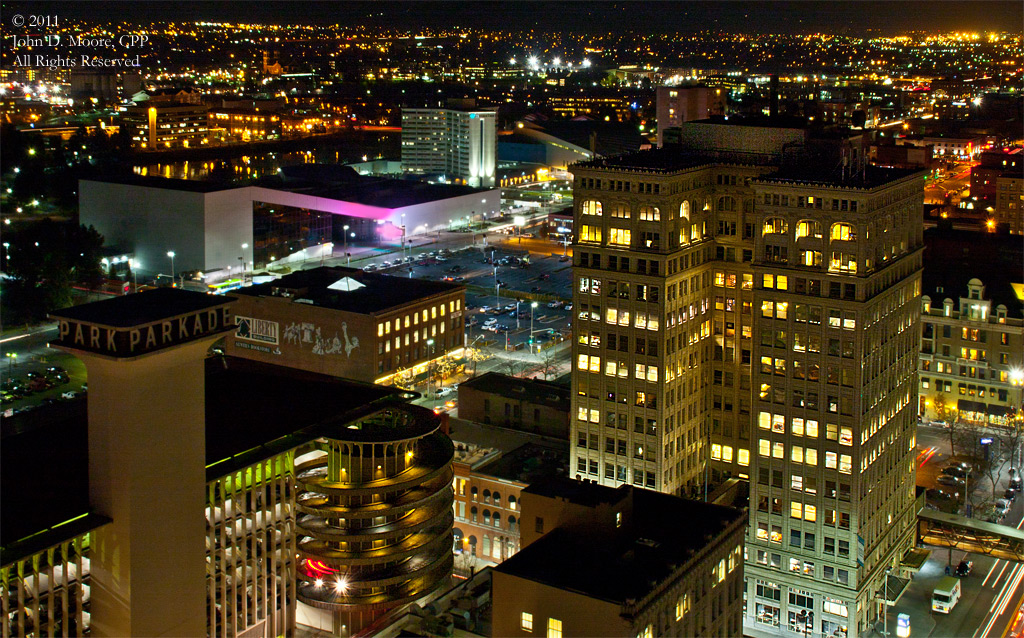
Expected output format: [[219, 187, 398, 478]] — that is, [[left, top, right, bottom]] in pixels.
[[401, 109, 498, 186]]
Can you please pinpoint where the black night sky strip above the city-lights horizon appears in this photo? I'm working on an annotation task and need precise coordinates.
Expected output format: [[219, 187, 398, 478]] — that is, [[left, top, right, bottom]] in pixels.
[[3, 0, 1024, 35]]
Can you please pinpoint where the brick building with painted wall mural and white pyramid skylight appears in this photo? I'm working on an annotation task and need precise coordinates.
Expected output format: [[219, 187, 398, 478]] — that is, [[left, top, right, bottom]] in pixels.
[[224, 267, 466, 383]]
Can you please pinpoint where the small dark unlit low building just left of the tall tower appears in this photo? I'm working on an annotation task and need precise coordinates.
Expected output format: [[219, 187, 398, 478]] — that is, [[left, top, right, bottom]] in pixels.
[[459, 372, 569, 439]]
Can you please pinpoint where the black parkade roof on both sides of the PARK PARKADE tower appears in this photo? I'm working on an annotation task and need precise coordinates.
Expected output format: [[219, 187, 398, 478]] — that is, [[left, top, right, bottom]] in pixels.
[[0, 356, 403, 547]]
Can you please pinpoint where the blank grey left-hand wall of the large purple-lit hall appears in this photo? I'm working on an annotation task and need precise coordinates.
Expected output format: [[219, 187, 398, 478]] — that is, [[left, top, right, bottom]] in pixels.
[[78, 179, 209, 274]]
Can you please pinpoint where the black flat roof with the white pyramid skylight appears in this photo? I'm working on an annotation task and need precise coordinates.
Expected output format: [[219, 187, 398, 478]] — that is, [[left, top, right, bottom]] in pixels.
[[231, 266, 465, 314]]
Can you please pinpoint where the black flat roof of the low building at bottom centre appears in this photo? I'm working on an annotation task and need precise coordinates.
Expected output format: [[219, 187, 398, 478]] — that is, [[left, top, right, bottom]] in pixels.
[[496, 479, 745, 604]]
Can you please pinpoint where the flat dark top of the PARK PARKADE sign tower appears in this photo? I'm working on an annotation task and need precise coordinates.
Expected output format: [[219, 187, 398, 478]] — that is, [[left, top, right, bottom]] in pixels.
[[50, 288, 234, 328]]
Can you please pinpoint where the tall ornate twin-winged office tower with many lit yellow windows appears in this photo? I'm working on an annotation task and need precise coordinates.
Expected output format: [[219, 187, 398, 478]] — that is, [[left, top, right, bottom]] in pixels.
[[571, 121, 923, 635]]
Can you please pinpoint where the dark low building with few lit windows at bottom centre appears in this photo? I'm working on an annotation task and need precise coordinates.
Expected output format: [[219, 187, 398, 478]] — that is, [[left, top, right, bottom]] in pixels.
[[492, 478, 746, 638]]
